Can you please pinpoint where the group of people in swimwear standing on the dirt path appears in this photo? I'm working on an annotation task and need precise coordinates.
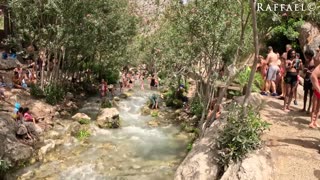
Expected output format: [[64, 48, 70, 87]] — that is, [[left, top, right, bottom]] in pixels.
[[257, 44, 320, 128]]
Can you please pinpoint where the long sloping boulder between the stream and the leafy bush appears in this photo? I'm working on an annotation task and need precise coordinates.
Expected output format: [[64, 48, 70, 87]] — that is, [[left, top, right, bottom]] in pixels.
[[174, 121, 223, 180]]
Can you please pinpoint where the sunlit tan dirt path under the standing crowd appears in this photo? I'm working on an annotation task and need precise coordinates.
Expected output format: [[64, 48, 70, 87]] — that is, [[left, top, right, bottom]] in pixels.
[[261, 97, 320, 180]]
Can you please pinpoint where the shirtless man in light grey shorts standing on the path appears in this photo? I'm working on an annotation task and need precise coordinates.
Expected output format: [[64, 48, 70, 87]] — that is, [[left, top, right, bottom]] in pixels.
[[266, 46, 279, 96]]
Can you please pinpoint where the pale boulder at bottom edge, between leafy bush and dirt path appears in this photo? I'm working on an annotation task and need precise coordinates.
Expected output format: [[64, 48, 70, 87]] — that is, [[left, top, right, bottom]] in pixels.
[[221, 147, 274, 180]]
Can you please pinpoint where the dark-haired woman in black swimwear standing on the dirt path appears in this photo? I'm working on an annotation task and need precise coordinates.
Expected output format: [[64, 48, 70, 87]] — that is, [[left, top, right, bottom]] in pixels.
[[283, 50, 298, 112]]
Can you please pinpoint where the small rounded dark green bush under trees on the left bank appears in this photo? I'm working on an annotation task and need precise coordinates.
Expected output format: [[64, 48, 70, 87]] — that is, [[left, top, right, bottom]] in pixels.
[[44, 84, 65, 105]]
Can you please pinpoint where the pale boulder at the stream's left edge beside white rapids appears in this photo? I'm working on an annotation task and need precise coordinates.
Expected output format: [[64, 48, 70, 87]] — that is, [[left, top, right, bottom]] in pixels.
[[97, 108, 120, 128]]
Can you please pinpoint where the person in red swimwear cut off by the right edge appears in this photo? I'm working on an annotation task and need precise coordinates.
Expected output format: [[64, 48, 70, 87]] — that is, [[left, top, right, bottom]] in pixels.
[[309, 49, 320, 128]]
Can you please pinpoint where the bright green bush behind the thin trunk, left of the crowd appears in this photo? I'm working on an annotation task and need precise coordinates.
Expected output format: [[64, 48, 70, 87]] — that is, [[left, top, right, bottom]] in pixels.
[[235, 67, 264, 95]]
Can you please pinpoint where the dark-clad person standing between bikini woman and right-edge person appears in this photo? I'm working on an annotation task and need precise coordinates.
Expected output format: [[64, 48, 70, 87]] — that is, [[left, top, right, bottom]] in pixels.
[[301, 49, 315, 113]]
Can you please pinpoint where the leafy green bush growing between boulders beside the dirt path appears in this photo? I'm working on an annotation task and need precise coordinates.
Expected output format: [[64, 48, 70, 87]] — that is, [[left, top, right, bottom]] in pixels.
[[217, 104, 269, 167]]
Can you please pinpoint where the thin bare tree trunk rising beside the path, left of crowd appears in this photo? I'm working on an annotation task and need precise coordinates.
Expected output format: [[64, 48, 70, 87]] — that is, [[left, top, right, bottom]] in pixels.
[[243, 0, 259, 107]]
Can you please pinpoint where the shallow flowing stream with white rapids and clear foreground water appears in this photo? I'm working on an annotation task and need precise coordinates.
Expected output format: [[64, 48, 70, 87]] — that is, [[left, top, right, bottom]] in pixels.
[[13, 91, 189, 180]]
